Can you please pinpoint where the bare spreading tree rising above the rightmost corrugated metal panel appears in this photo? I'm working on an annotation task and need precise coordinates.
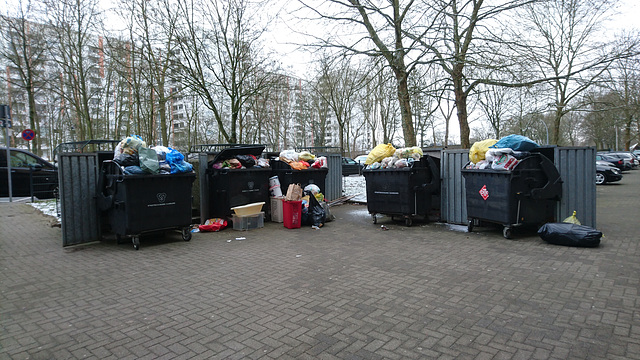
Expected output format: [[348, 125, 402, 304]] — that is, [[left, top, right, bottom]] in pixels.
[[521, 0, 637, 145]]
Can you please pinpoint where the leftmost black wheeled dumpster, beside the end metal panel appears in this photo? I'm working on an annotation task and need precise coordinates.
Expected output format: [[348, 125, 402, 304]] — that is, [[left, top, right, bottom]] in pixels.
[[99, 160, 196, 250]]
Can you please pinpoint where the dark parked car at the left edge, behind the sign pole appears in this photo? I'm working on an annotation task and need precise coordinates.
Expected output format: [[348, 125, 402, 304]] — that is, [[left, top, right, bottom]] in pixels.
[[0, 147, 58, 199]]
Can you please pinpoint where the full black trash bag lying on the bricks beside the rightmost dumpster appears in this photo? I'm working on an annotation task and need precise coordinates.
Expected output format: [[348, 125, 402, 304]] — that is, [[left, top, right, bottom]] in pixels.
[[538, 223, 602, 247]]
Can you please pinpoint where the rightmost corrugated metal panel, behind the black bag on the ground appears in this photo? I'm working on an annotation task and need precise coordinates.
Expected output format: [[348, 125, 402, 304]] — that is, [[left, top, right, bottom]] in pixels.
[[553, 147, 596, 228]]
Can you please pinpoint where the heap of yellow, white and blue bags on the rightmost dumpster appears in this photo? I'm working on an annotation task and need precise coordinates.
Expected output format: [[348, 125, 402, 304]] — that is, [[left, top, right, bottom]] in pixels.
[[465, 135, 539, 170]]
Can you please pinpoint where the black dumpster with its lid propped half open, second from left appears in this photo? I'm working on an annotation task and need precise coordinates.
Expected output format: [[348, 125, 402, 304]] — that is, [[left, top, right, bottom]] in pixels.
[[201, 145, 271, 221]]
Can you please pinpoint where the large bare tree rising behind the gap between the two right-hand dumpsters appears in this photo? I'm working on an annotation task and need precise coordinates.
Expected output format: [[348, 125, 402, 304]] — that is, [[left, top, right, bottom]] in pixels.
[[400, 0, 536, 148]]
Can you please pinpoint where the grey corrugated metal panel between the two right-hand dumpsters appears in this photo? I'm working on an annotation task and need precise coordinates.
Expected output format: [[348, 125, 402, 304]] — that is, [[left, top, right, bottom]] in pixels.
[[440, 149, 469, 225]]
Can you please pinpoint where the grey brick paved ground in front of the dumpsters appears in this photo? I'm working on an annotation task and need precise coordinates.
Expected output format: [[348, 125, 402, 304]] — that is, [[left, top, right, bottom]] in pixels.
[[0, 171, 640, 359]]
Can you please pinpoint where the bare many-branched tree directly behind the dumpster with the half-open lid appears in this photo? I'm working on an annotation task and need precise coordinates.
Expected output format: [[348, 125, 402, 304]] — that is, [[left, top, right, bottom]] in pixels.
[[177, 0, 272, 143]]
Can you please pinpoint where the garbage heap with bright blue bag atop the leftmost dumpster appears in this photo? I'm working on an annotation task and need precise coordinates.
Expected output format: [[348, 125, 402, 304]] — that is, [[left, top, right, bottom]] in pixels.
[[113, 135, 193, 175]]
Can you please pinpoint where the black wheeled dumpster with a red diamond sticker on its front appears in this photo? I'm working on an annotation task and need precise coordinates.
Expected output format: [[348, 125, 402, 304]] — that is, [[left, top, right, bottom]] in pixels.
[[462, 153, 562, 239]]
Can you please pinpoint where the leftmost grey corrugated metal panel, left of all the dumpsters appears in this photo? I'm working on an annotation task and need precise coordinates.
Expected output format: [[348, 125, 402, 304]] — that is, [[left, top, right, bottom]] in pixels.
[[58, 153, 101, 246]]
